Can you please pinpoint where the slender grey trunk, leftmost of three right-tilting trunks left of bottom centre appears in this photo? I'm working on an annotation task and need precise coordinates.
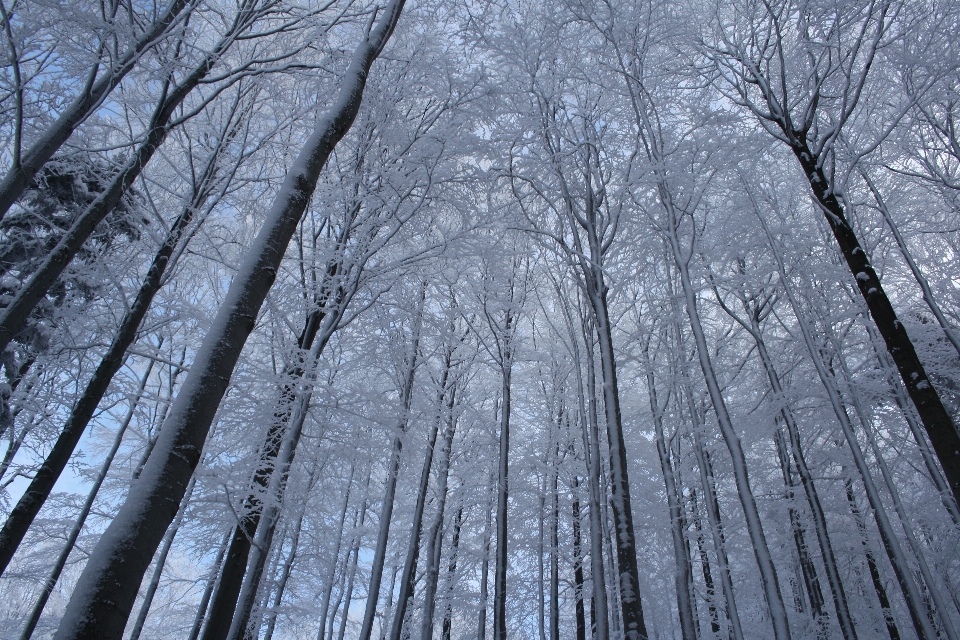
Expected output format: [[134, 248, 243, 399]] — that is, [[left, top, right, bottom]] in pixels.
[[360, 302, 426, 640]]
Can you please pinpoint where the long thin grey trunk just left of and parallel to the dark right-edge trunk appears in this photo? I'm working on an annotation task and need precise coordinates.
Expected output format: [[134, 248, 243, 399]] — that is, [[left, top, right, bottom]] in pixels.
[[758, 212, 937, 640]]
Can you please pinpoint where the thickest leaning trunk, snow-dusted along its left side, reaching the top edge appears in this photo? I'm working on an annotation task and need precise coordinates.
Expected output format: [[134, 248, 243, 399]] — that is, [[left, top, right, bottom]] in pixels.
[[56, 0, 404, 640]]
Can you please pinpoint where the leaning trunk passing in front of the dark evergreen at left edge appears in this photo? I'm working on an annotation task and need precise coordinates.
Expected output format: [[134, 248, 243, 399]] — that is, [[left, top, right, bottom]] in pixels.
[[0, 2, 257, 353]]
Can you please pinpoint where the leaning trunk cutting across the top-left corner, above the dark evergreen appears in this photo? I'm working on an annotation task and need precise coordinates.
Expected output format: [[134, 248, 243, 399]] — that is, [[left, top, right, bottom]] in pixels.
[[0, 0, 199, 219]]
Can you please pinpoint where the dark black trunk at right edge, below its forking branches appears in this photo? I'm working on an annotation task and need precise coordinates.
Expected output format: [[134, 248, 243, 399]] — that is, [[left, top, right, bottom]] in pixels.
[[792, 150, 960, 504]]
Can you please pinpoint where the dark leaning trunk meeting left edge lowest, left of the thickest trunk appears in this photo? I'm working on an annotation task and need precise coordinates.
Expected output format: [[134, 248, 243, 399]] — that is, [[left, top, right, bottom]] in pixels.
[[0, 114, 233, 575]]
